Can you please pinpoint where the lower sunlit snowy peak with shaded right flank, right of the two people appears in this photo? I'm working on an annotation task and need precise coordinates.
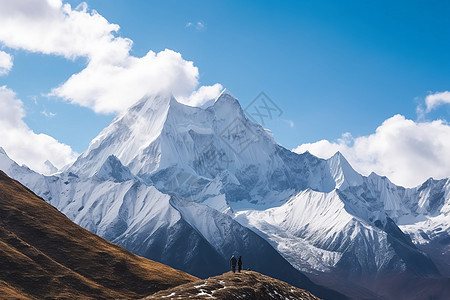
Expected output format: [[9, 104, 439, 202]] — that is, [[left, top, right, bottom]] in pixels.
[[236, 189, 437, 276]]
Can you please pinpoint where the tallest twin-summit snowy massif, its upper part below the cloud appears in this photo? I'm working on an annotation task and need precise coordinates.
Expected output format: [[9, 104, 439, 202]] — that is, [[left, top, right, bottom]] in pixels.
[[69, 91, 335, 208]]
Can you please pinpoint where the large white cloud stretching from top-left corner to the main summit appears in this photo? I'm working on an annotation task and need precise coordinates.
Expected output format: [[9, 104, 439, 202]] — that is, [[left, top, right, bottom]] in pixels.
[[0, 0, 218, 113]]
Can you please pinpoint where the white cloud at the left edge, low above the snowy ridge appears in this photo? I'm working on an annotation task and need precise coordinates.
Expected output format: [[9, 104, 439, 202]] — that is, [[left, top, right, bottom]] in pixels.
[[0, 86, 77, 173]]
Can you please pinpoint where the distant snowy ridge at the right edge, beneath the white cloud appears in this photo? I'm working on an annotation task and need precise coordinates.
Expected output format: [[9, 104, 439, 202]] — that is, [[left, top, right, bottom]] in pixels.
[[342, 173, 450, 244]]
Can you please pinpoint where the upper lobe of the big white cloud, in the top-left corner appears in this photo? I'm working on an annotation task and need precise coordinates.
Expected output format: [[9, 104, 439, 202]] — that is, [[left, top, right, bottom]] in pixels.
[[0, 0, 132, 62]]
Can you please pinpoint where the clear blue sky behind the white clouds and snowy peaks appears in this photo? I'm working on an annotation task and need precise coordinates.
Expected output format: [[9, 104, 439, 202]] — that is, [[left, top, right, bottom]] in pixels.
[[0, 0, 450, 186]]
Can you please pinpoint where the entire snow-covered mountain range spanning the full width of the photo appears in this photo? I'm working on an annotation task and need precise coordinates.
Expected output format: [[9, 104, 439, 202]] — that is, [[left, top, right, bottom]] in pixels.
[[0, 91, 450, 296]]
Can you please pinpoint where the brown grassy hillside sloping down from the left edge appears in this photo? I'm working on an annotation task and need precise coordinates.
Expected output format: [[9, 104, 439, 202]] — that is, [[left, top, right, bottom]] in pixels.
[[0, 171, 197, 299]]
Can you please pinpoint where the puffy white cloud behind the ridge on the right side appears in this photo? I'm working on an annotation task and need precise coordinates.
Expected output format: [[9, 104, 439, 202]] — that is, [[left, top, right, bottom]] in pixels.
[[293, 115, 450, 187]]
